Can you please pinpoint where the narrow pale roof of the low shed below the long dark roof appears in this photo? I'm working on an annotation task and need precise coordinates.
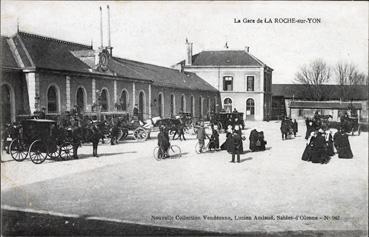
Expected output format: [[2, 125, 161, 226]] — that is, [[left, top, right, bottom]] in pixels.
[[289, 101, 362, 110]]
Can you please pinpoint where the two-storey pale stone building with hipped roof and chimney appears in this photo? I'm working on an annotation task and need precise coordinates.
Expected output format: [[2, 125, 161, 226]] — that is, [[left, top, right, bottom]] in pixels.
[[173, 42, 273, 120]]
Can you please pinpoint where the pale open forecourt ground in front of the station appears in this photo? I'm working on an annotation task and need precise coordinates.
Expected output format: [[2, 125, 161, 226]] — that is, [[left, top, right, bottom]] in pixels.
[[1, 122, 368, 236]]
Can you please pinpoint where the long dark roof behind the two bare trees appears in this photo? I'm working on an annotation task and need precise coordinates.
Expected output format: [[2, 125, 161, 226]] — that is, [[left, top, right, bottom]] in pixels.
[[272, 84, 368, 100]]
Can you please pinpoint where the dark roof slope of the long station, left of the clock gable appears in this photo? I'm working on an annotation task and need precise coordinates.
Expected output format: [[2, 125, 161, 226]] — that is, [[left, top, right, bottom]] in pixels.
[[13, 32, 92, 72]]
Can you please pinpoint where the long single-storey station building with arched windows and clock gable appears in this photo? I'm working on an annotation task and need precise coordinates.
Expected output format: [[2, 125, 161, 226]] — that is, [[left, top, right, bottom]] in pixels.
[[1, 32, 219, 122]]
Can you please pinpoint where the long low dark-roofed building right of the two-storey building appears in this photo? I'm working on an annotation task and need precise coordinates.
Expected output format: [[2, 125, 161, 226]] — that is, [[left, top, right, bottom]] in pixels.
[[272, 84, 368, 120]]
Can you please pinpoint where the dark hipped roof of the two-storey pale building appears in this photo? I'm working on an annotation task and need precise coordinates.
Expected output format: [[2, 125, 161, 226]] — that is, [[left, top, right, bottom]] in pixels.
[[180, 50, 265, 67]]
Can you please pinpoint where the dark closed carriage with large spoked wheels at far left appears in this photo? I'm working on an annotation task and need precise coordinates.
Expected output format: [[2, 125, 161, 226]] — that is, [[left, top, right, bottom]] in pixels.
[[9, 119, 73, 164]]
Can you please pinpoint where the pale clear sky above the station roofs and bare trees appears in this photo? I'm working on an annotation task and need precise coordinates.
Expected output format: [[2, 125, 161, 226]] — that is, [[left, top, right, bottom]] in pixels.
[[1, 1, 368, 84]]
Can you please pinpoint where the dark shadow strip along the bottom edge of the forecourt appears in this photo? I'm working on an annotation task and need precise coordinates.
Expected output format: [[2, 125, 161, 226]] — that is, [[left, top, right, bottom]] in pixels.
[[1, 209, 367, 237]]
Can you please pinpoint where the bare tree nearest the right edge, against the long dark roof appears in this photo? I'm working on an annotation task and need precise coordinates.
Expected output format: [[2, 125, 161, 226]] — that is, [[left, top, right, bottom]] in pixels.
[[334, 62, 367, 100]]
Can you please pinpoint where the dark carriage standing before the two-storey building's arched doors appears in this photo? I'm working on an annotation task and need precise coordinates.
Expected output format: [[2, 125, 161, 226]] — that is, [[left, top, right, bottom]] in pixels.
[[210, 112, 245, 130]]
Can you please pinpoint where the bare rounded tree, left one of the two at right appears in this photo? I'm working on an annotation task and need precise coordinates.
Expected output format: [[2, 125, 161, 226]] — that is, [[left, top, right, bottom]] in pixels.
[[295, 59, 333, 101]]
